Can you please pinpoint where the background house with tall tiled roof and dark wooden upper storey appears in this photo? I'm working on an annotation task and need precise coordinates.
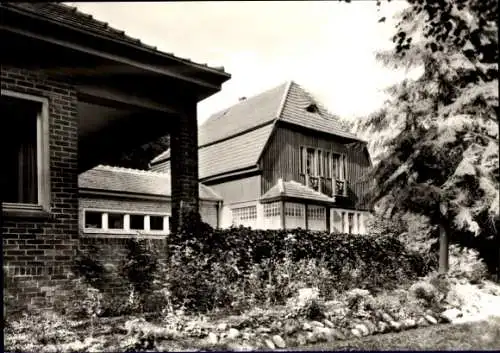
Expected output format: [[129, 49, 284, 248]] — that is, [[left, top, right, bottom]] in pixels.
[[151, 82, 371, 233]]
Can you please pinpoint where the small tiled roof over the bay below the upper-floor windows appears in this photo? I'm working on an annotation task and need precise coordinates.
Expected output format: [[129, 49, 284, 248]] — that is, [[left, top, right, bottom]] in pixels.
[[260, 179, 335, 203]]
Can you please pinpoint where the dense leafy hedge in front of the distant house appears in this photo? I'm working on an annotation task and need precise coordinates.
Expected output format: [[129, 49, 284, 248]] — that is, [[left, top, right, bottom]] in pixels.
[[168, 210, 430, 310]]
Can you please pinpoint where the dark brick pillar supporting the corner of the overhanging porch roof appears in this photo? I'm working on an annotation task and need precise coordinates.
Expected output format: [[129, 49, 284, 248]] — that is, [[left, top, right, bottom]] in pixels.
[[170, 101, 199, 232]]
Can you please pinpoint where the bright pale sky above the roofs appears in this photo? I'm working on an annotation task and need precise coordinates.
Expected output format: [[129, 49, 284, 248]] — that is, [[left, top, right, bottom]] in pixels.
[[68, 0, 406, 124]]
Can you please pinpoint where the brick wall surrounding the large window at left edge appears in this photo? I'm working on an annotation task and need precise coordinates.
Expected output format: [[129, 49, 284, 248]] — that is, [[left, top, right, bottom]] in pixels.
[[1, 66, 78, 305]]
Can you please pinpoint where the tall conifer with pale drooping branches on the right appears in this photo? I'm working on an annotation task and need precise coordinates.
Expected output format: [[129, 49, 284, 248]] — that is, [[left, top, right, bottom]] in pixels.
[[350, 0, 500, 274]]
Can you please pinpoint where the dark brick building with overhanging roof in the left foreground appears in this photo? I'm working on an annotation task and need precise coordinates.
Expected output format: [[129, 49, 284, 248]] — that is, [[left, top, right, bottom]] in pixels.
[[0, 3, 230, 304]]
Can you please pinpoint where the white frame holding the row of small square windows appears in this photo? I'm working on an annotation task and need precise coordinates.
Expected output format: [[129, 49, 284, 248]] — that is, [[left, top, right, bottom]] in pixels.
[[81, 207, 171, 235]]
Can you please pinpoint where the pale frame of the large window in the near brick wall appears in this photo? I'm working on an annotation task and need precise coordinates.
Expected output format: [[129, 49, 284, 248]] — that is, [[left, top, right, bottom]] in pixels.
[[1, 89, 51, 215]]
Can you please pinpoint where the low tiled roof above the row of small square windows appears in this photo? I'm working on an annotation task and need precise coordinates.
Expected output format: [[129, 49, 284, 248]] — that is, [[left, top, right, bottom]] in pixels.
[[78, 165, 222, 201]]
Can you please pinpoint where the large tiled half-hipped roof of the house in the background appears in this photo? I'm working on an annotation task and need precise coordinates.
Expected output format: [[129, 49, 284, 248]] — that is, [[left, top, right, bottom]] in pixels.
[[151, 81, 360, 179]]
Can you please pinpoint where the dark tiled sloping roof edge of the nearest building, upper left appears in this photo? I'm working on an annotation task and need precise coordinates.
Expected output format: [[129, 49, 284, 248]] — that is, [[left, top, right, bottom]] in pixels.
[[1, 2, 229, 75]]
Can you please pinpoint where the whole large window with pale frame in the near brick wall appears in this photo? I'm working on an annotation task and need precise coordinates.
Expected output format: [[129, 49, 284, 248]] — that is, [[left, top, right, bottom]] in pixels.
[[0, 90, 50, 210]]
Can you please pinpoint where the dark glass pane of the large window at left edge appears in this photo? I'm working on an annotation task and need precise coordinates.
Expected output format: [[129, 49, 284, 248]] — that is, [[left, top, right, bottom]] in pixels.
[[0, 96, 41, 204]]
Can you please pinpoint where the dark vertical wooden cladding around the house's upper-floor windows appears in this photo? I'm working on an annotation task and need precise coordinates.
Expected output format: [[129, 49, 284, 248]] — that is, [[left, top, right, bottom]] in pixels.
[[261, 125, 370, 208]]
